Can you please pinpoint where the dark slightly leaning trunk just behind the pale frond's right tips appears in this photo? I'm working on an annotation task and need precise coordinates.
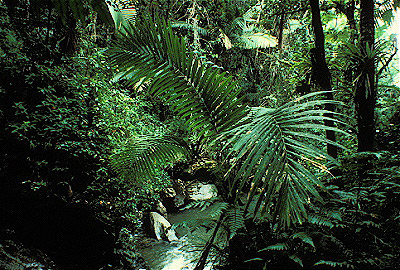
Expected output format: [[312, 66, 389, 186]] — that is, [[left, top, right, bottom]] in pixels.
[[310, 0, 338, 158]]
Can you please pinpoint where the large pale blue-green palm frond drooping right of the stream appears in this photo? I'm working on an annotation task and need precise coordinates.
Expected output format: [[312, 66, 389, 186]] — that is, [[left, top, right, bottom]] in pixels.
[[224, 92, 349, 225]]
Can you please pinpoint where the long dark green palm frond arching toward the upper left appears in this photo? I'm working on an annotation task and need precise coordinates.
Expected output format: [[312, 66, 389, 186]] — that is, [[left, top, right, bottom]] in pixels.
[[109, 17, 247, 136]]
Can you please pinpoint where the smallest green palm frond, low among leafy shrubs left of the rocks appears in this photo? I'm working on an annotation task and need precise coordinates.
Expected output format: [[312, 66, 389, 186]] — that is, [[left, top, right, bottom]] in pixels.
[[111, 135, 188, 183]]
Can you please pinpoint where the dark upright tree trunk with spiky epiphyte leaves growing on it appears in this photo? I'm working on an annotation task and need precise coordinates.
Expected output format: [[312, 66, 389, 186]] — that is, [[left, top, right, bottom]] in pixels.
[[355, 0, 376, 152]]
